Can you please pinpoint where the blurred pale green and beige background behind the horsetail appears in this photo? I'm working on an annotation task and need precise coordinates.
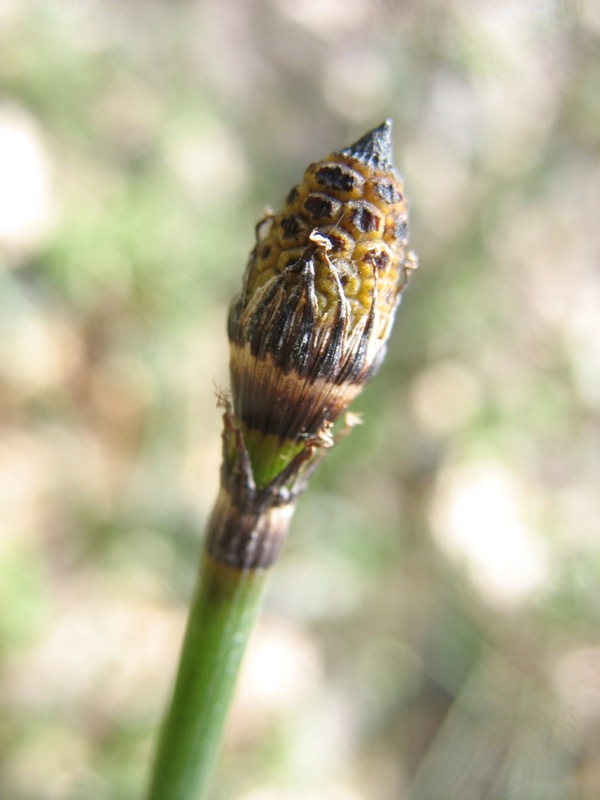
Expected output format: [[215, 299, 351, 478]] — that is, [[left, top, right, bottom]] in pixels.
[[0, 0, 600, 800]]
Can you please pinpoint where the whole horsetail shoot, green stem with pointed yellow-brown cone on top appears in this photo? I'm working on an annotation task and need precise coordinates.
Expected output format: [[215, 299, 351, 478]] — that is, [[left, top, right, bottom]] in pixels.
[[148, 120, 416, 800]]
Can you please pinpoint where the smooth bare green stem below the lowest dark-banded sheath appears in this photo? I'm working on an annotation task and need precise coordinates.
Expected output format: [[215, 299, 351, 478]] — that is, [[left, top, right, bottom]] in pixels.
[[147, 555, 269, 800]]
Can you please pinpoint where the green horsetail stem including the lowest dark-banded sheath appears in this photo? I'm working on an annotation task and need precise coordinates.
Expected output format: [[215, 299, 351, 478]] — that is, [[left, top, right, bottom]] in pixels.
[[147, 468, 292, 800]]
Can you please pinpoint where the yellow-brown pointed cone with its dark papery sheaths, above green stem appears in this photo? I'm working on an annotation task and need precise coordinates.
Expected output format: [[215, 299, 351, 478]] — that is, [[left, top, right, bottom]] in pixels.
[[209, 120, 416, 568]]
